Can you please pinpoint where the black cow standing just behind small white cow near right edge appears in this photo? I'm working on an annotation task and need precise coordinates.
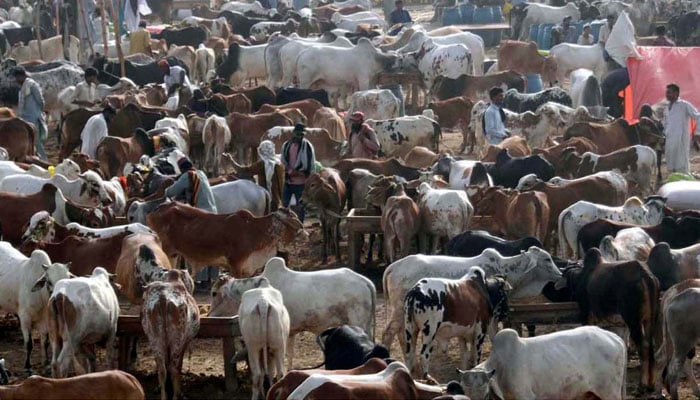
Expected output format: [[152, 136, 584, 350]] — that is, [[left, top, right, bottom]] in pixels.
[[577, 217, 700, 254]]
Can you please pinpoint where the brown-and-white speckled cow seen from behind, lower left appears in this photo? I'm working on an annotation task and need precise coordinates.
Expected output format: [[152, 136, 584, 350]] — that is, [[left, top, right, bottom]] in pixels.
[[141, 270, 198, 399]]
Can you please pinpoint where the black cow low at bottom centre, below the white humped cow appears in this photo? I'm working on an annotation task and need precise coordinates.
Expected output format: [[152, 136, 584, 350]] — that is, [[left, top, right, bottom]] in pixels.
[[316, 325, 389, 369]]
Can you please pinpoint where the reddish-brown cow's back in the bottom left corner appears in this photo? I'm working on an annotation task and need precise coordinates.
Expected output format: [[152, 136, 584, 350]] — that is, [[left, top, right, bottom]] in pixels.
[[0, 370, 146, 400]]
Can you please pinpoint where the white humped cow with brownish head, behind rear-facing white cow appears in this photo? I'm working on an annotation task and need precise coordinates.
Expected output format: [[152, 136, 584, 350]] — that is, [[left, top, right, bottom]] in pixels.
[[209, 257, 377, 368]]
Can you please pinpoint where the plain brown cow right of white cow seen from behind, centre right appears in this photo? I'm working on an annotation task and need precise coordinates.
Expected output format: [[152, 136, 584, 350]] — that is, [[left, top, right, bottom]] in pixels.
[[473, 187, 550, 243]]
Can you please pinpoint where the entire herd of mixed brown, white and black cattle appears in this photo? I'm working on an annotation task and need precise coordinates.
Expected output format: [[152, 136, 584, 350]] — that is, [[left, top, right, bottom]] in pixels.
[[0, 0, 700, 399]]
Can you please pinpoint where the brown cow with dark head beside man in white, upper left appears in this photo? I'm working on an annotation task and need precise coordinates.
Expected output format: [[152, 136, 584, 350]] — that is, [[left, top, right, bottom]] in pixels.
[[95, 129, 155, 177]]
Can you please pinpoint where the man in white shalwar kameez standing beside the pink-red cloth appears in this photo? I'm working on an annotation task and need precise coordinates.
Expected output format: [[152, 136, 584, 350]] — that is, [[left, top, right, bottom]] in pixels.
[[664, 83, 700, 174]]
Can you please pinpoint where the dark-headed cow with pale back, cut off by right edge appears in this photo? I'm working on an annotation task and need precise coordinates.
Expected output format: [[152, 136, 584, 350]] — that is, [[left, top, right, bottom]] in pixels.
[[647, 242, 700, 290]]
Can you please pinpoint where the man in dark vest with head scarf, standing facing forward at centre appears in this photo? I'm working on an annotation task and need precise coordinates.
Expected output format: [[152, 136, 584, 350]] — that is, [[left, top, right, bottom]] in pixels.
[[282, 124, 316, 222]]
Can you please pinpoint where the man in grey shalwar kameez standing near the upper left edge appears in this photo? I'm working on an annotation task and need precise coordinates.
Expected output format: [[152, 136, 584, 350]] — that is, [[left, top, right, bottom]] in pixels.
[[14, 67, 47, 160]]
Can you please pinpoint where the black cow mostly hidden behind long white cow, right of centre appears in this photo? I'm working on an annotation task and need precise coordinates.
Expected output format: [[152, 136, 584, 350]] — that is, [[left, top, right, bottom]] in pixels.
[[447, 231, 543, 257]]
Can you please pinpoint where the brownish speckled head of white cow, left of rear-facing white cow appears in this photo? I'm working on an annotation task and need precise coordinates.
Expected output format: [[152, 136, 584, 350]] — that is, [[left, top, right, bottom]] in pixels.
[[208, 274, 270, 317]]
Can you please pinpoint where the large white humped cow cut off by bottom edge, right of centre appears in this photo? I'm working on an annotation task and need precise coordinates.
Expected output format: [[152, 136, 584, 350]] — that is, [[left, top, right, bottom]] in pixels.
[[459, 326, 627, 400]]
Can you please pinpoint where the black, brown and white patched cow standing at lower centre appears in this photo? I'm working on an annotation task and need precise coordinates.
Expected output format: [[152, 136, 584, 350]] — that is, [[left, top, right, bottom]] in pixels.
[[404, 267, 510, 379]]
